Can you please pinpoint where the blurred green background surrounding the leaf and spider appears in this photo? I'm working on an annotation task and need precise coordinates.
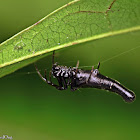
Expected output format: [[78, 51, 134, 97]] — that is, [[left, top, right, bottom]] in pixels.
[[0, 0, 140, 140]]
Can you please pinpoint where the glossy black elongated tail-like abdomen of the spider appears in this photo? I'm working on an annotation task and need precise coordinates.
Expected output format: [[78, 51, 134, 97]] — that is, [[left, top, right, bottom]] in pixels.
[[76, 69, 135, 102]]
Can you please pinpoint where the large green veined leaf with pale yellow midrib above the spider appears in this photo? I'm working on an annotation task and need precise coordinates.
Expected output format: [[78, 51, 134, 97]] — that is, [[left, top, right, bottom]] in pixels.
[[0, 0, 140, 77]]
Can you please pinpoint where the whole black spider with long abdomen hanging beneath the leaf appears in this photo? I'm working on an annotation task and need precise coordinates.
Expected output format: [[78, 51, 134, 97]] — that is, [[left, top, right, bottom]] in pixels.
[[35, 51, 135, 102]]
